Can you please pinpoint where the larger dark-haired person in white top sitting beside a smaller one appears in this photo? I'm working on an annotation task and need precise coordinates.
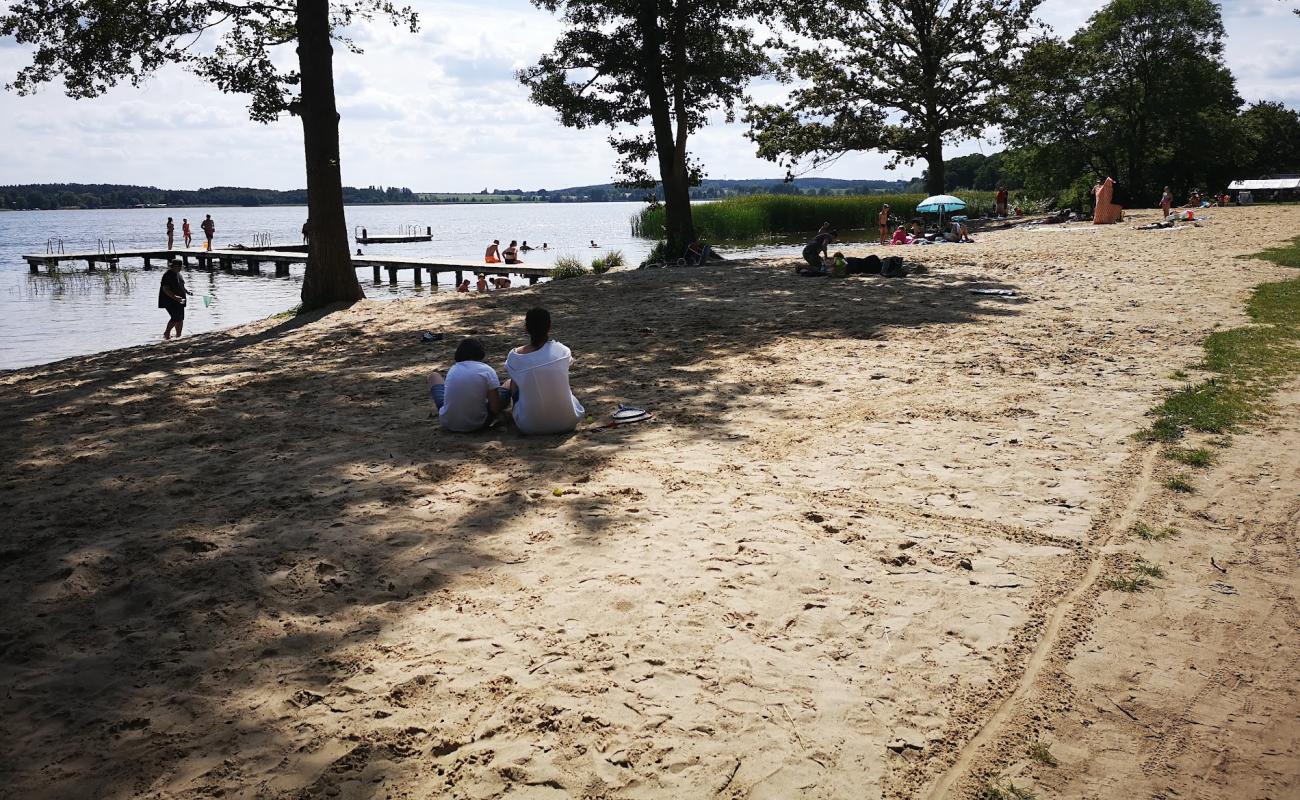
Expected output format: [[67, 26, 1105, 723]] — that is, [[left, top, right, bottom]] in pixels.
[[506, 308, 586, 434]]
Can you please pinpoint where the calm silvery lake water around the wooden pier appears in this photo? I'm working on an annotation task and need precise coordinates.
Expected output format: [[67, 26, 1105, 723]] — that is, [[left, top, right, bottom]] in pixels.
[[0, 203, 696, 369]]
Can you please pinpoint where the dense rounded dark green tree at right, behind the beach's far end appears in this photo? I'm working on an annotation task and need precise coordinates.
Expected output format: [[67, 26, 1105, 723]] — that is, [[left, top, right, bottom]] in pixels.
[[1004, 0, 1242, 206]]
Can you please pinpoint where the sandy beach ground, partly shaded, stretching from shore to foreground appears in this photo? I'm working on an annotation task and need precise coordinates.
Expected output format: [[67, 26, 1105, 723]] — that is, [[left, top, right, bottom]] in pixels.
[[0, 207, 1300, 799]]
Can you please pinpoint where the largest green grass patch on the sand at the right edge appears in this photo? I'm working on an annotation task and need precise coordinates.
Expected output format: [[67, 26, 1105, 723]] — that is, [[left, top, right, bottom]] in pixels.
[[1139, 237, 1300, 442]]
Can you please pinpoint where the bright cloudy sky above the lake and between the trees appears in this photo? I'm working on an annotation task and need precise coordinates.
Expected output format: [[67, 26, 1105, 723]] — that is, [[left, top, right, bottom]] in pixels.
[[0, 0, 1300, 191]]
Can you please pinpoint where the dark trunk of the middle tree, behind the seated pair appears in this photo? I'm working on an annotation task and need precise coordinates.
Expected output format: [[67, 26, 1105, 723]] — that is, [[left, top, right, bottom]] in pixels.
[[637, 0, 696, 258]]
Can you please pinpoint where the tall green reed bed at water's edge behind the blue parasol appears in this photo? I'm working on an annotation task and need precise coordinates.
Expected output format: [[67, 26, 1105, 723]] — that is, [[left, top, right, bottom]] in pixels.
[[632, 191, 993, 242]]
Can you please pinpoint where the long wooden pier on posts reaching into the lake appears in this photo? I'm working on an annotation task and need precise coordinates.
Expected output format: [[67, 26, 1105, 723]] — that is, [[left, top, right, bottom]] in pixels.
[[22, 248, 551, 286]]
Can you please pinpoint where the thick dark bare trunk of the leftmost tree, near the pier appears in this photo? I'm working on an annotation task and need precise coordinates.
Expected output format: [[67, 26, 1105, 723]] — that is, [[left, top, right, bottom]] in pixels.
[[296, 0, 365, 311]]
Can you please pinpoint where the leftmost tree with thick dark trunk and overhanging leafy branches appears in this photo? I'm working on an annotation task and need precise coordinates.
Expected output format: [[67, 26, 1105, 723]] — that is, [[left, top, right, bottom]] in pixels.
[[0, 0, 417, 310]]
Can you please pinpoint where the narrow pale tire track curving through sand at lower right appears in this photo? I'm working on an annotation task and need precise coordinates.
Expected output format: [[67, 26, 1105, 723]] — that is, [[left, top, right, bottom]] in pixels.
[[926, 445, 1158, 800]]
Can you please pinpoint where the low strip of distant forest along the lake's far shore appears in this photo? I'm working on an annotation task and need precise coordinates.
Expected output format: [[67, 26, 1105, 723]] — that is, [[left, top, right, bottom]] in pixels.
[[0, 178, 930, 209]]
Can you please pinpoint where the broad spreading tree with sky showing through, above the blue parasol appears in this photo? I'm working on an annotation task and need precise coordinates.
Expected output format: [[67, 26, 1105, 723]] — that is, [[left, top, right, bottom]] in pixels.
[[745, 0, 1041, 194]]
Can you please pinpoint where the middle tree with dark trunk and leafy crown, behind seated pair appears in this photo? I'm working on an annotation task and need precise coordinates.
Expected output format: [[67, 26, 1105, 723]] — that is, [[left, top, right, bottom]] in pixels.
[[519, 0, 770, 255]]
